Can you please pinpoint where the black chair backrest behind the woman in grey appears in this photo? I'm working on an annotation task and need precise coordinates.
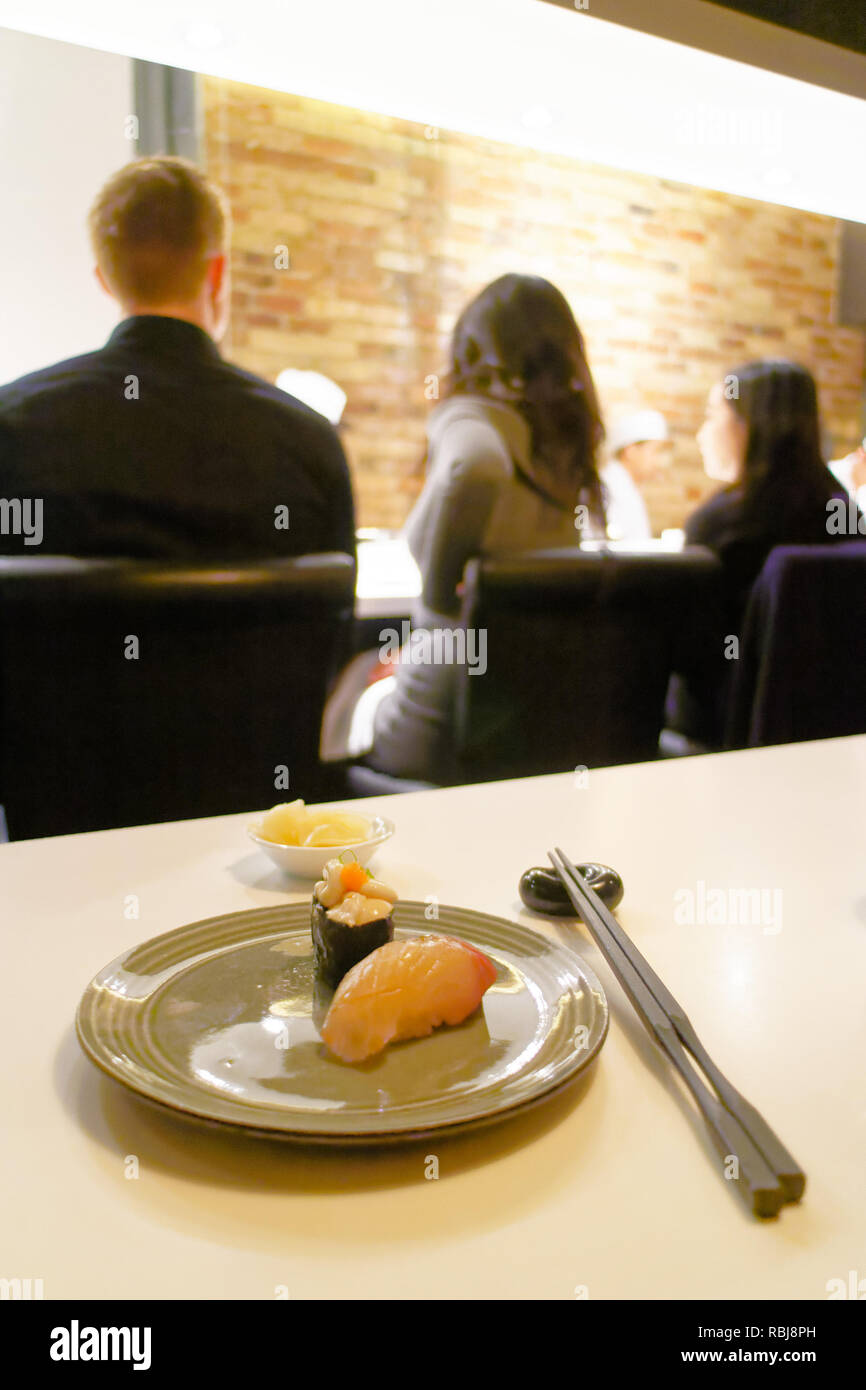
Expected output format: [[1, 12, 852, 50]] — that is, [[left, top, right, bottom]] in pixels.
[[452, 546, 720, 781]]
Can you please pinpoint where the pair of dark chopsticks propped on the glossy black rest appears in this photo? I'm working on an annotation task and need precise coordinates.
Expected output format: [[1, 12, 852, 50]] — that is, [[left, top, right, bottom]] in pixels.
[[549, 849, 806, 1216]]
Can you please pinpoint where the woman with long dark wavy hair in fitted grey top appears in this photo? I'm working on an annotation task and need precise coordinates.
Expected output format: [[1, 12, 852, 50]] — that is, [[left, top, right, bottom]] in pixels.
[[332, 274, 605, 781]]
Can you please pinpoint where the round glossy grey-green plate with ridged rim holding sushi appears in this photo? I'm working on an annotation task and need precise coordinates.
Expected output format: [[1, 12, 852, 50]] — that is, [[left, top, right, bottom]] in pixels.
[[75, 902, 609, 1144]]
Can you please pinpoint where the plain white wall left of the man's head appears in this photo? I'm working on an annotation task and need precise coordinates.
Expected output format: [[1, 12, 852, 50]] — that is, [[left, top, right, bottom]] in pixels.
[[0, 29, 135, 382]]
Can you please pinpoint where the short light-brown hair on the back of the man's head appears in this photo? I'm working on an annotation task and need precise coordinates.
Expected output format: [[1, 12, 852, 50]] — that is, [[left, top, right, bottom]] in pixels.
[[88, 154, 229, 307]]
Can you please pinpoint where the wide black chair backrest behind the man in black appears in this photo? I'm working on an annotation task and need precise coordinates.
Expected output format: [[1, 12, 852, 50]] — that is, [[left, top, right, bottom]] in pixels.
[[0, 555, 354, 840]]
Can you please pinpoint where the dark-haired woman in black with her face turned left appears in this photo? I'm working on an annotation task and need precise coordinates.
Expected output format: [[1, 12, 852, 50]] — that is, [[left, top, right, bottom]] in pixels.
[[666, 360, 849, 748]]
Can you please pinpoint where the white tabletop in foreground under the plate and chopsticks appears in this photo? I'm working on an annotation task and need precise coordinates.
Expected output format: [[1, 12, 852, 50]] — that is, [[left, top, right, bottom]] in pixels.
[[0, 737, 866, 1301]]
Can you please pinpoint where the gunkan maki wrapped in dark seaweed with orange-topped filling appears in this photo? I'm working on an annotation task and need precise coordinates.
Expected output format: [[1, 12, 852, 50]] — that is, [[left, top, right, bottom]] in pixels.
[[311, 858, 398, 986]]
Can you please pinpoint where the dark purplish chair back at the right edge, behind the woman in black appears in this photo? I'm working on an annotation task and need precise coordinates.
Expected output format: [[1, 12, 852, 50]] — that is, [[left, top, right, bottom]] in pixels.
[[726, 541, 866, 748]]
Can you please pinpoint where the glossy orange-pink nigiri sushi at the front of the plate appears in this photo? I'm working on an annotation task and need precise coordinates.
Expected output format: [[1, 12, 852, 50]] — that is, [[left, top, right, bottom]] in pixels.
[[321, 935, 496, 1062]]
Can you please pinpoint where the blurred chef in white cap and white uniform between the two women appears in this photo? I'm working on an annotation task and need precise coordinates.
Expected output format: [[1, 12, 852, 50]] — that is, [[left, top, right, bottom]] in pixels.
[[602, 410, 669, 541]]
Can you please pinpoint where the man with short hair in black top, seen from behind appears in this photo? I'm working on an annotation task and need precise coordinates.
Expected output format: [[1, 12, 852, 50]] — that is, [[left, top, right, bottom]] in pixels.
[[0, 158, 354, 562]]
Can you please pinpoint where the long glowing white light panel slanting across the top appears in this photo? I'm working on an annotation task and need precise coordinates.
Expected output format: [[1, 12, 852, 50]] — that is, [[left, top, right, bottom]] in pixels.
[[6, 0, 866, 222]]
